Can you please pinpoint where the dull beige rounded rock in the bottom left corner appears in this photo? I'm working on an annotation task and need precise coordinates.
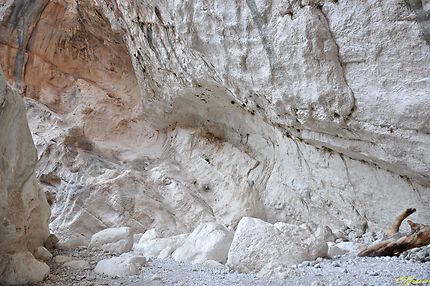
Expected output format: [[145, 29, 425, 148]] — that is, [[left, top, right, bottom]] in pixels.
[[0, 252, 49, 285]]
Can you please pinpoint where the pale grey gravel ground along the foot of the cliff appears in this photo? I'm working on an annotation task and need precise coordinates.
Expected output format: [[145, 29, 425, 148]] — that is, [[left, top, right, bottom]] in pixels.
[[34, 246, 430, 286]]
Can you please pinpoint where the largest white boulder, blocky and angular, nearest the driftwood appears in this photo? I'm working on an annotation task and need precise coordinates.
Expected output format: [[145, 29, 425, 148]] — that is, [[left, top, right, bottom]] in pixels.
[[227, 217, 328, 273]]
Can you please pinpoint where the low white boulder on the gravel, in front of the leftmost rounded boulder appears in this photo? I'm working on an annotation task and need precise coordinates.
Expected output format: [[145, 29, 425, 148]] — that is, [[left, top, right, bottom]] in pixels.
[[94, 253, 146, 277]]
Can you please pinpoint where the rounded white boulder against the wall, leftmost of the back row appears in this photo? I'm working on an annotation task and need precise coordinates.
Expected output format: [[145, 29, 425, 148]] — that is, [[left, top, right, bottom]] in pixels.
[[89, 227, 133, 254]]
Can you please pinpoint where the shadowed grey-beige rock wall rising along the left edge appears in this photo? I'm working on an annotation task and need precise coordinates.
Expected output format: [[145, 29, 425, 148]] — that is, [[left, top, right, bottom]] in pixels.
[[0, 70, 50, 285]]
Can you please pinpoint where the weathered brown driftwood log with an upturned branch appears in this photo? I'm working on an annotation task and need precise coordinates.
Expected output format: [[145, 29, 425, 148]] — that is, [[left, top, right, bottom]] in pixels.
[[358, 209, 430, 256]]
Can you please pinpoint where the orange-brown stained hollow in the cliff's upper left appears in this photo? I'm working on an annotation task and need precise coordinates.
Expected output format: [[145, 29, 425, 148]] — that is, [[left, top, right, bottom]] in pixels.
[[0, 0, 137, 113]]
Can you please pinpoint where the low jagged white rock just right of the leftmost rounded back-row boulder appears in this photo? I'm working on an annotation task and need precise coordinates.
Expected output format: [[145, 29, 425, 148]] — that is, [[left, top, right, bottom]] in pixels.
[[133, 230, 189, 258]]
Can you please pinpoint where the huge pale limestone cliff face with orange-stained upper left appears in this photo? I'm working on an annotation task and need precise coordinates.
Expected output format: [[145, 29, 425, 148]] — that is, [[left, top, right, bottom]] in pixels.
[[0, 0, 430, 246]]
